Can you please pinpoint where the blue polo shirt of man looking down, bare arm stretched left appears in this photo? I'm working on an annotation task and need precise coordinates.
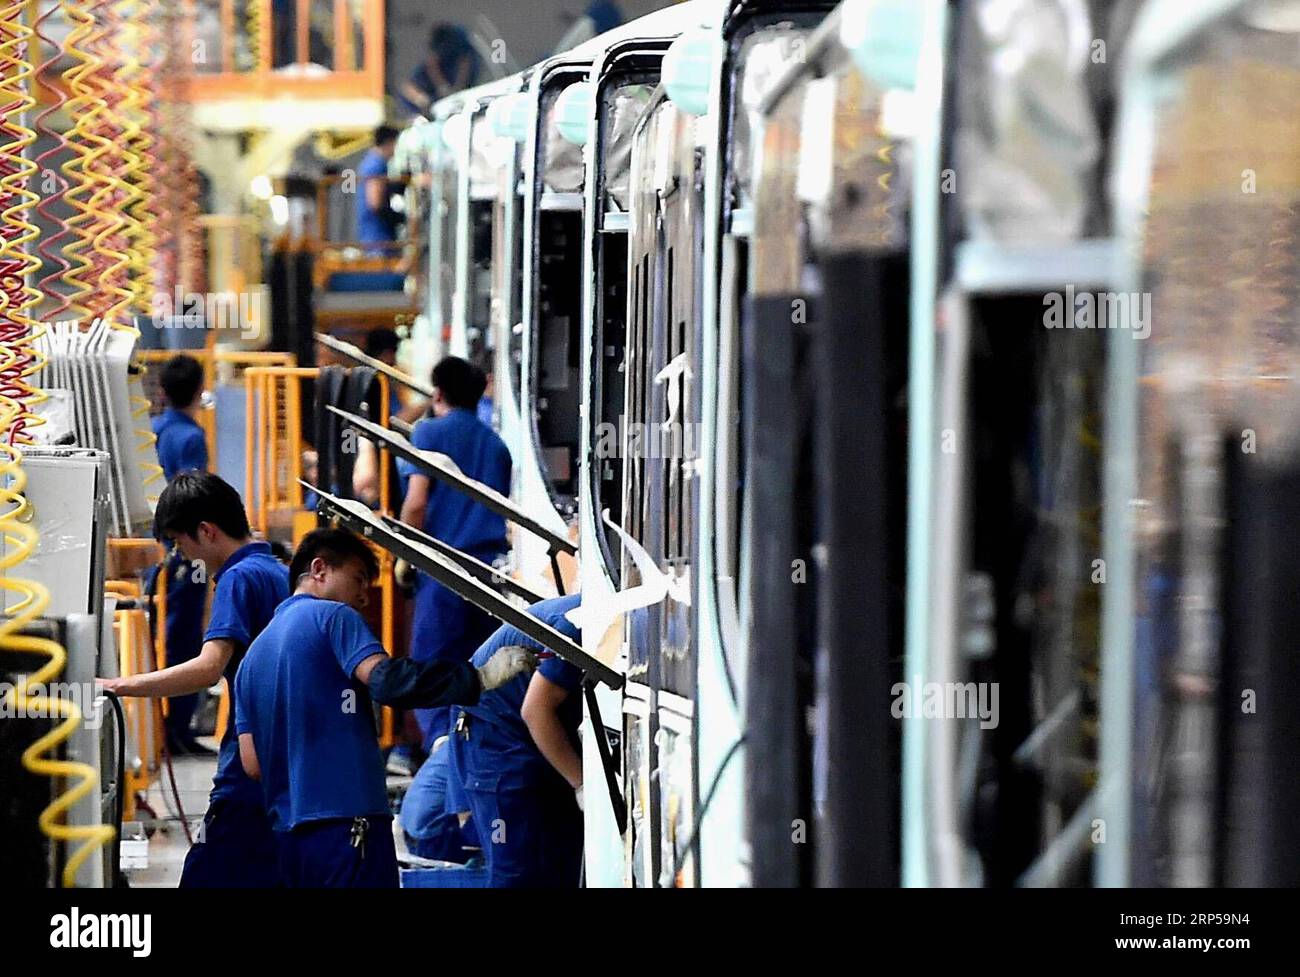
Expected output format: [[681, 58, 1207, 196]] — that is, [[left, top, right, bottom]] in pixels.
[[203, 542, 289, 800]]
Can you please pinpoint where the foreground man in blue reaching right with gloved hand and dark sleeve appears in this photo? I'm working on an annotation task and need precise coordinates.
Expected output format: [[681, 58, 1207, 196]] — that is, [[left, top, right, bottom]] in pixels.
[[235, 529, 536, 889]]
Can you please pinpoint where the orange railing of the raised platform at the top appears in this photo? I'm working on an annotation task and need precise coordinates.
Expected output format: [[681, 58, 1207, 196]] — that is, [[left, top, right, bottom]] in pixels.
[[186, 0, 385, 101]]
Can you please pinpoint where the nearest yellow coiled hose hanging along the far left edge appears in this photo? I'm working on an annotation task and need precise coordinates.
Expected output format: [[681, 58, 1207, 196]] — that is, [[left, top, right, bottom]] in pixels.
[[0, 0, 114, 886]]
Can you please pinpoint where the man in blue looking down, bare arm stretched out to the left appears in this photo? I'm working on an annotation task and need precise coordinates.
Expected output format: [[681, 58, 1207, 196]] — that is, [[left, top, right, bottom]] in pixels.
[[101, 472, 289, 889]]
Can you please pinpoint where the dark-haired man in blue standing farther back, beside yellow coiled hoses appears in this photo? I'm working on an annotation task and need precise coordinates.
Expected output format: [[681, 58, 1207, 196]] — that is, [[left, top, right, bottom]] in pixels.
[[144, 353, 212, 756]]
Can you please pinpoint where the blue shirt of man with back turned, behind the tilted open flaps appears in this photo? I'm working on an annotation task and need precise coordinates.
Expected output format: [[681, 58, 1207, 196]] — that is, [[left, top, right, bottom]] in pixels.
[[398, 408, 511, 561]]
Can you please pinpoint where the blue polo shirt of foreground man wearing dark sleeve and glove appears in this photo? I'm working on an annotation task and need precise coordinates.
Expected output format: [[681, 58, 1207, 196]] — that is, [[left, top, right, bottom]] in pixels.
[[235, 594, 389, 831]]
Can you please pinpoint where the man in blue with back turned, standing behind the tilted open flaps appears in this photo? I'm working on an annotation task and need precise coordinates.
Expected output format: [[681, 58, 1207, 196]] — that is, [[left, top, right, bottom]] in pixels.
[[399, 356, 511, 752]]
